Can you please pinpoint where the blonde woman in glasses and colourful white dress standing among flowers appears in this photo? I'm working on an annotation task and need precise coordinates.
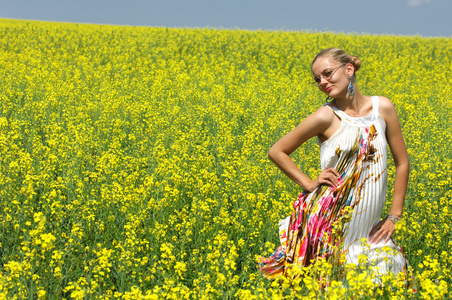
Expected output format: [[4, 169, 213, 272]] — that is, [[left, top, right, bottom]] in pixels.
[[260, 48, 410, 278]]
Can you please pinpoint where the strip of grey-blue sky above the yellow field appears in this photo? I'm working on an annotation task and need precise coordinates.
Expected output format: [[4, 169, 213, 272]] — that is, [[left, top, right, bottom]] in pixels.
[[0, 0, 452, 37]]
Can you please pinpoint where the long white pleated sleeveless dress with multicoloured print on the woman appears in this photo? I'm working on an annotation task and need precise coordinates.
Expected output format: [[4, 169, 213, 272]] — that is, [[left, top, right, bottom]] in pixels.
[[259, 96, 408, 281]]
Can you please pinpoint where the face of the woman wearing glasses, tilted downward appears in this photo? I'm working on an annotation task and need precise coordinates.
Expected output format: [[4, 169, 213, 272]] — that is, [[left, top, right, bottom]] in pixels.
[[312, 57, 353, 98]]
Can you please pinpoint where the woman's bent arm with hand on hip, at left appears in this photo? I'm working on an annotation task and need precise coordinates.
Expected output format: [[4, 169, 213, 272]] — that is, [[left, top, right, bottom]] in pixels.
[[268, 107, 339, 191]]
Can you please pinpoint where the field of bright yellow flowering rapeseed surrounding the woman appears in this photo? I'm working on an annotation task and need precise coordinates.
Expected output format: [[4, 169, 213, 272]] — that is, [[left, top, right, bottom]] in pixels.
[[0, 20, 452, 299]]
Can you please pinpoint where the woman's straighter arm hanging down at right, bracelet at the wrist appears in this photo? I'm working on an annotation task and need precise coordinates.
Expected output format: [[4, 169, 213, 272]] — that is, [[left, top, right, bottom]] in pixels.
[[370, 97, 410, 243]]
